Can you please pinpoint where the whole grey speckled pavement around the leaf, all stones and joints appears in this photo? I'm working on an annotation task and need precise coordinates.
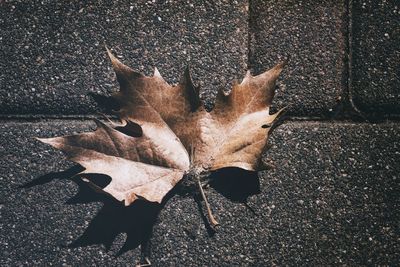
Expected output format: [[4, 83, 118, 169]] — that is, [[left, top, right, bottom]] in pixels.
[[0, 0, 400, 266]]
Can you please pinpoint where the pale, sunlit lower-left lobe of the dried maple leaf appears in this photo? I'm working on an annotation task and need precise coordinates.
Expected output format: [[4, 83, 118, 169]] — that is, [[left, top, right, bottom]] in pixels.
[[39, 120, 189, 205]]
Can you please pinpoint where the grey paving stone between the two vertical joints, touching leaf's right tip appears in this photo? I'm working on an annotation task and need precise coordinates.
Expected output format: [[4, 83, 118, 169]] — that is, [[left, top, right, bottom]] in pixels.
[[249, 0, 347, 117]]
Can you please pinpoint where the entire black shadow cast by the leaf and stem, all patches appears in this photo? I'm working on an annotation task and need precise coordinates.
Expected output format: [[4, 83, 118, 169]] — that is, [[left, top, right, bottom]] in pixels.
[[24, 165, 260, 257]]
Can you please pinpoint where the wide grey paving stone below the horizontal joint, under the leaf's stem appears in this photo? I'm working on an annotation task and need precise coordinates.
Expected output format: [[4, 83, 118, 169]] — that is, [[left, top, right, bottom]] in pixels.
[[0, 120, 400, 266]]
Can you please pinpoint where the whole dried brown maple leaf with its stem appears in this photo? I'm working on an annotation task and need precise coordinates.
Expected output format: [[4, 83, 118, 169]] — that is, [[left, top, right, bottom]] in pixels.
[[39, 50, 284, 224]]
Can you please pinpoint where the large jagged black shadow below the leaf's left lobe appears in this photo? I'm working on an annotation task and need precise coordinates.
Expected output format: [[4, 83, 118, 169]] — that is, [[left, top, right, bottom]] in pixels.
[[20, 165, 169, 256]]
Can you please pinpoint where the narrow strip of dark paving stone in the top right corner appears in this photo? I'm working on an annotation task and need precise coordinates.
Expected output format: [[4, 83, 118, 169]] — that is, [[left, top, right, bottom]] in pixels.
[[351, 0, 400, 115]]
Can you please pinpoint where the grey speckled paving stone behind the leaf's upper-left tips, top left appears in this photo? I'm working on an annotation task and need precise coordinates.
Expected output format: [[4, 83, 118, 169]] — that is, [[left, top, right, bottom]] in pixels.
[[0, 0, 248, 114]]
